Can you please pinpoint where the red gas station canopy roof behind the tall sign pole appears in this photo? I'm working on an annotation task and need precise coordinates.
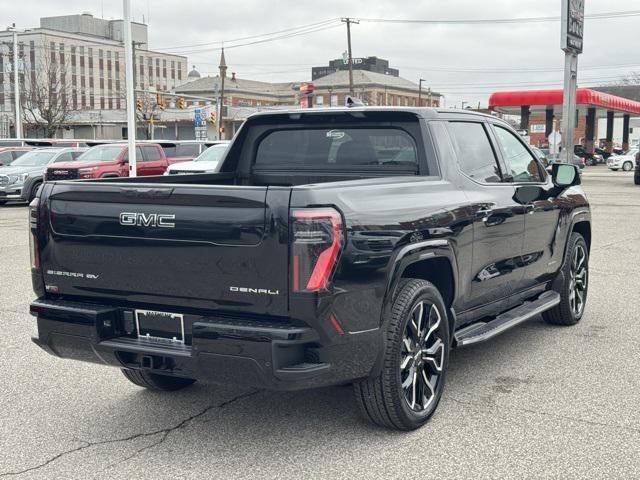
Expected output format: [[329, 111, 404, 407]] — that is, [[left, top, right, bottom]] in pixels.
[[489, 88, 640, 117]]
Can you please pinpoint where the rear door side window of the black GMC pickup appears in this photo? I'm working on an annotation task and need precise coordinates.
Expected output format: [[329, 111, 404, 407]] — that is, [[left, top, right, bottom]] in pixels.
[[449, 122, 502, 183]]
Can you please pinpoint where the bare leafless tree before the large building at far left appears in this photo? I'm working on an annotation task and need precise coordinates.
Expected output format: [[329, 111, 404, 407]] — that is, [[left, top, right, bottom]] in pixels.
[[21, 43, 73, 138]]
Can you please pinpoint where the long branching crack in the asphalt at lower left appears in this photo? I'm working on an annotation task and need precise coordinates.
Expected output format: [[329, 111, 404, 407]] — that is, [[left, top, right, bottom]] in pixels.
[[0, 390, 260, 478]]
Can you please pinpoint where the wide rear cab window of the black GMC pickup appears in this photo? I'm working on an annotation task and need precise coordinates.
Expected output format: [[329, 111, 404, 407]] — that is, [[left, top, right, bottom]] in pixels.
[[255, 127, 418, 170]]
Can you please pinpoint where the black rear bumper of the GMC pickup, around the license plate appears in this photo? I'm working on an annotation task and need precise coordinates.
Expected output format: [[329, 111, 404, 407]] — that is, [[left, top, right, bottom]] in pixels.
[[30, 299, 380, 390]]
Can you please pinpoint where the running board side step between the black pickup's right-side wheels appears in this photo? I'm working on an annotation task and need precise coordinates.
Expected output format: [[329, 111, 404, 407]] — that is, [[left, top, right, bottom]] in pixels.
[[454, 291, 560, 347]]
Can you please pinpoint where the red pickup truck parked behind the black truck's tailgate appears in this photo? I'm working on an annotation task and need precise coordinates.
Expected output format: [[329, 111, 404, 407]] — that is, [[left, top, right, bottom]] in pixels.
[[46, 143, 169, 180]]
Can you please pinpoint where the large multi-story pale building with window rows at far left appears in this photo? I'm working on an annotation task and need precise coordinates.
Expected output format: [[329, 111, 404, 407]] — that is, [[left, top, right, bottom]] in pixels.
[[0, 13, 187, 138]]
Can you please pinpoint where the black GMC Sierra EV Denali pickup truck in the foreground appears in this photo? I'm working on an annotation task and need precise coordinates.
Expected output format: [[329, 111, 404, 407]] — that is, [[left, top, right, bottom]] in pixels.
[[30, 107, 591, 430]]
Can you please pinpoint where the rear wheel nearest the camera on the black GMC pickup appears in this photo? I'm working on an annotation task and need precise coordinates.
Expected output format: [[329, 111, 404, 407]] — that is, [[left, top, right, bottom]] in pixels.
[[353, 279, 450, 430]]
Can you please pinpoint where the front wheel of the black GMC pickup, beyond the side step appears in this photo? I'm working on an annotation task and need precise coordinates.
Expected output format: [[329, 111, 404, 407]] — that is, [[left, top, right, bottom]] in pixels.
[[542, 232, 589, 325]]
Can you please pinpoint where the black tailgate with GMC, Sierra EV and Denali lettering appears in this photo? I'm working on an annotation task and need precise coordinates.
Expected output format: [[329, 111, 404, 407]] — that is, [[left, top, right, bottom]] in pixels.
[[41, 182, 290, 315]]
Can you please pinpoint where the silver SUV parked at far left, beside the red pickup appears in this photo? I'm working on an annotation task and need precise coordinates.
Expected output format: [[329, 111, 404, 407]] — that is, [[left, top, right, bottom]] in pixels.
[[0, 147, 86, 205]]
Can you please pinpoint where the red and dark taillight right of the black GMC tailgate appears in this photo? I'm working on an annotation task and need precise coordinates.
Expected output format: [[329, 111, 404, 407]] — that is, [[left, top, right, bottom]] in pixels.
[[291, 208, 342, 292]]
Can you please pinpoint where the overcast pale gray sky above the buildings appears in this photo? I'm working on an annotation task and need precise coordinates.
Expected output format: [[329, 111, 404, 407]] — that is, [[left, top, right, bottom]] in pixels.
[[0, 0, 640, 106]]
